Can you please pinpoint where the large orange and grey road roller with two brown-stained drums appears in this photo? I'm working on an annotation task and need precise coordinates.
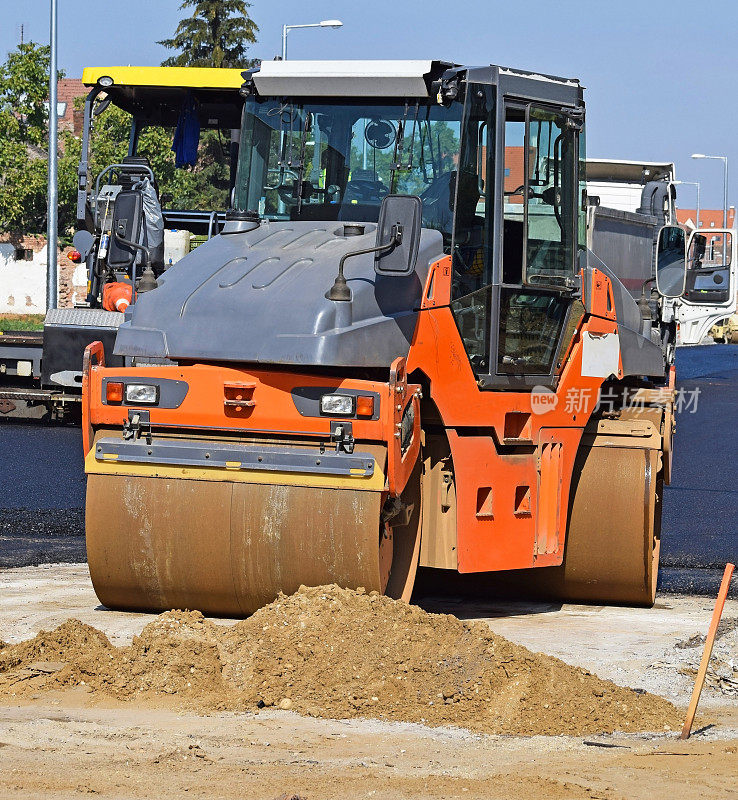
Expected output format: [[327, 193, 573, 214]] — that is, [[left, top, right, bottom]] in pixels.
[[83, 61, 686, 615]]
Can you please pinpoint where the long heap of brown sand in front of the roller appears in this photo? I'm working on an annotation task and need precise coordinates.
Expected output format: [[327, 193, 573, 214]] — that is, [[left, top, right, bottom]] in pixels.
[[0, 586, 679, 735]]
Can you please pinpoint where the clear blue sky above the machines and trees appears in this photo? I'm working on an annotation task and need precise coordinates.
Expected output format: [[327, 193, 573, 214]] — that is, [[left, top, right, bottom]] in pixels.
[[0, 0, 738, 208]]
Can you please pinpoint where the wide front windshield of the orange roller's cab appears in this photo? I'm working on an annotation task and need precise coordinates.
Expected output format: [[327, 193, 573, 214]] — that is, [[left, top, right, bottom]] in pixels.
[[236, 98, 462, 233]]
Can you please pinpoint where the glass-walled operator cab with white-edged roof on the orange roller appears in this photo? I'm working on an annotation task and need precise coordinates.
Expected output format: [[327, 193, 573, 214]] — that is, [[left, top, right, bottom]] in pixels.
[[235, 61, 586, 387]]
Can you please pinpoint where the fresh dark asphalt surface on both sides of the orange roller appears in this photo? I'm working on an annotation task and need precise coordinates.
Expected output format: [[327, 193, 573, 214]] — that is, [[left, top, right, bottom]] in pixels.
[[0, 345, 738, 595]]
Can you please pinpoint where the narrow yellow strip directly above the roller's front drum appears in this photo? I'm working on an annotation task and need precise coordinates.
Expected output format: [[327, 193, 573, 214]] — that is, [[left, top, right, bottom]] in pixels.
[[85, 449, 384, 492]]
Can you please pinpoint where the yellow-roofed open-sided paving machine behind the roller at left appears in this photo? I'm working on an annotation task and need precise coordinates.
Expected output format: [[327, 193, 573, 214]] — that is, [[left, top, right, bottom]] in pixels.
[[0, 67, 243, 419]]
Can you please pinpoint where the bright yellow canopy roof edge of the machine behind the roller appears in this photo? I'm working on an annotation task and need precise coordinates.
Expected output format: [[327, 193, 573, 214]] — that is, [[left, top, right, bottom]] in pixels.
[[82, 67, 243, 89]]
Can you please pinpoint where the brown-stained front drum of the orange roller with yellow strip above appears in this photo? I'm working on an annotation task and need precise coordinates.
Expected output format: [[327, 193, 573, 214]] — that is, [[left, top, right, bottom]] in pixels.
[[86, 440, 419, 616]]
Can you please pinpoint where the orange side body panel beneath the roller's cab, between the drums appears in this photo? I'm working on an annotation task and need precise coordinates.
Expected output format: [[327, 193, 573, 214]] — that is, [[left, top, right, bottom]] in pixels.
[[408, 257, 617, 572]]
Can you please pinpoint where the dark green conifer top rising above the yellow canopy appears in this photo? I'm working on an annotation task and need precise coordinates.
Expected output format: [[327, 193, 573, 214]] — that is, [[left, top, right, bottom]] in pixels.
[[157, 0, 259, 69]]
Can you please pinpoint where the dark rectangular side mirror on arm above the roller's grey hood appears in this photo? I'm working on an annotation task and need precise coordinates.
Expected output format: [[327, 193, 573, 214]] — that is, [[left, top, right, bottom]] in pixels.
[[374, 194, 423, 275]]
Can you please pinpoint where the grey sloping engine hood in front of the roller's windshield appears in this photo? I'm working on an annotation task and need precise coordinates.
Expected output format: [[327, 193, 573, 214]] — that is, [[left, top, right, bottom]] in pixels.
[[114, 222, 443, 367]]
